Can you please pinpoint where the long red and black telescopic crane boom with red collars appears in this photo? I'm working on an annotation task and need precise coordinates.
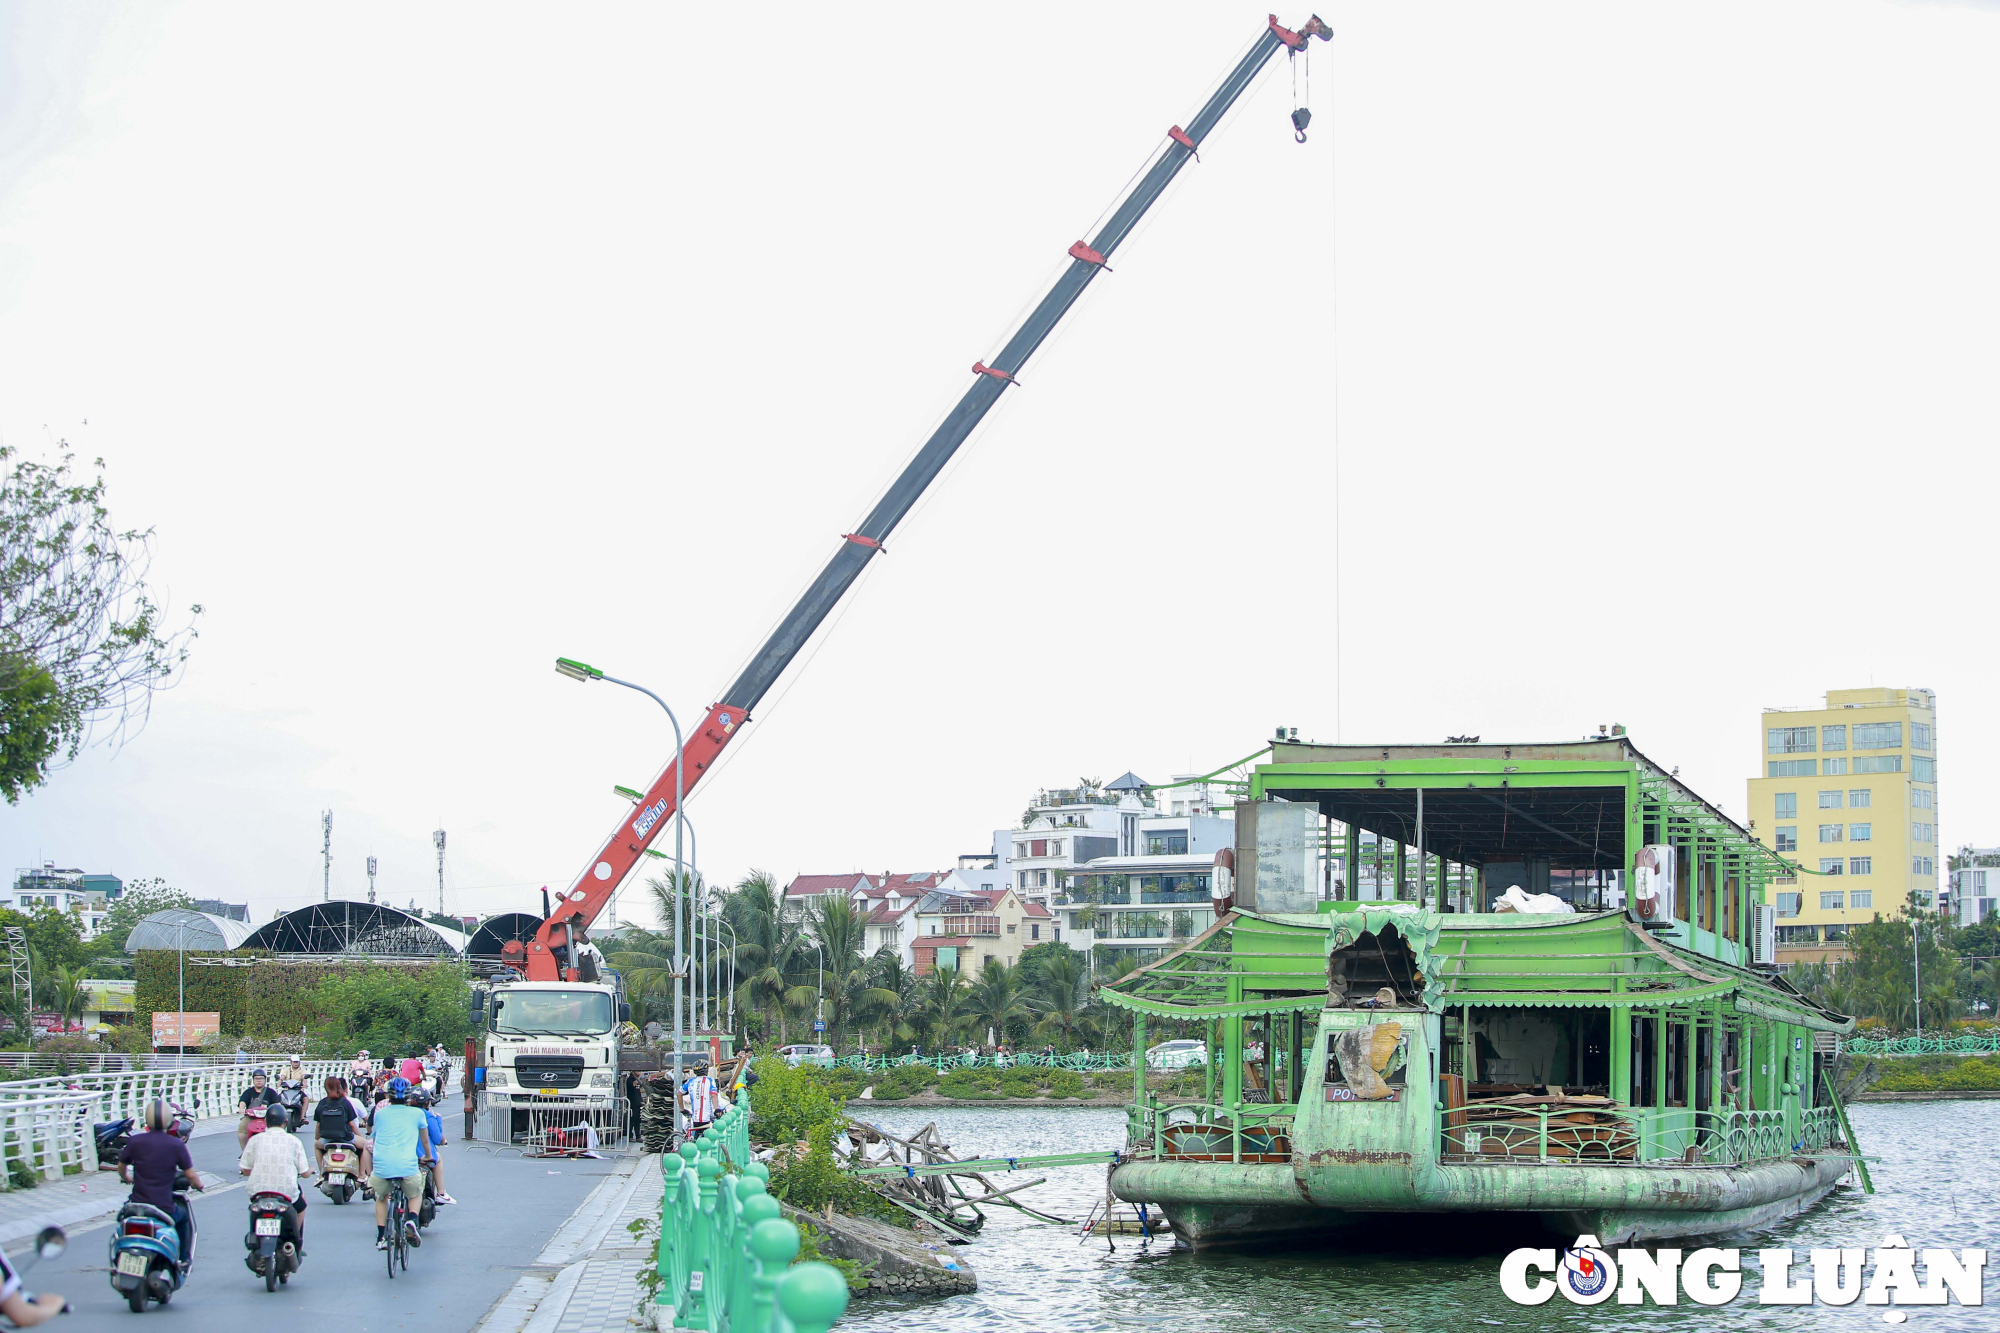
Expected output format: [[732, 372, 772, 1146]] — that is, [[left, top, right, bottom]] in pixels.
[[524, 14, 1332, 981]]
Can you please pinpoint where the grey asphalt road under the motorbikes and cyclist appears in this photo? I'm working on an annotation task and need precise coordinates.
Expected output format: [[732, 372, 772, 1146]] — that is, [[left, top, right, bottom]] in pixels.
[[16, 1103, 612, 1333]]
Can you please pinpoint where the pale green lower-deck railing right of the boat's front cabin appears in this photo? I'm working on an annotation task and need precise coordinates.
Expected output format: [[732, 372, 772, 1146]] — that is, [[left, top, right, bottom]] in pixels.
[[1438, 1103, 1840, 1167]]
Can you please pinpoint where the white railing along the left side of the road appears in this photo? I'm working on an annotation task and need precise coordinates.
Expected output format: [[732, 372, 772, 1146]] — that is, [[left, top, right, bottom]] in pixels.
[[0, 1057, 368, 1189]]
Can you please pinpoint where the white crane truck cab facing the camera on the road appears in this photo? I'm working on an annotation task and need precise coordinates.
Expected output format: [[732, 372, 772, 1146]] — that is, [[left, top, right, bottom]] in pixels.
[[478, 979, 630, 1143]]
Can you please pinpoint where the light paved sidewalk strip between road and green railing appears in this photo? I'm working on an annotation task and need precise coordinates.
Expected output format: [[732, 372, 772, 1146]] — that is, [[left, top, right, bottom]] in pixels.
[[478, 1155, 662, 1333]]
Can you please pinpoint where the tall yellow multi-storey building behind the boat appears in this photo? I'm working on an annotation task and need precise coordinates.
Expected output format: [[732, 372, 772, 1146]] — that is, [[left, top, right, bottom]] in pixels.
[[1750, 689, 1944, 963]]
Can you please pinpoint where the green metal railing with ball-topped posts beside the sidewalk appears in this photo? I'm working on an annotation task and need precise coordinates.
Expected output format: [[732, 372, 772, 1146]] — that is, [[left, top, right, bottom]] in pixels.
[[654, 1099, 848, 1333]]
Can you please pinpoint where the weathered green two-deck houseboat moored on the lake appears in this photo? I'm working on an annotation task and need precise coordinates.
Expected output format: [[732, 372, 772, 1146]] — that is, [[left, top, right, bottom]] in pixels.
[[1102, 737, 1856, 1249]]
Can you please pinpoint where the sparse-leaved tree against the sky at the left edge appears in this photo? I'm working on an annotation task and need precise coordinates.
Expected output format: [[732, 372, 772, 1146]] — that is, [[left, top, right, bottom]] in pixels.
[[0, 446, 202, 805]]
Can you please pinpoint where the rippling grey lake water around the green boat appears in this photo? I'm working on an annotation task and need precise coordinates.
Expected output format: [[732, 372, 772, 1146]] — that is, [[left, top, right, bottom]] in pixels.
[[840, 1101, 2000, 1333]]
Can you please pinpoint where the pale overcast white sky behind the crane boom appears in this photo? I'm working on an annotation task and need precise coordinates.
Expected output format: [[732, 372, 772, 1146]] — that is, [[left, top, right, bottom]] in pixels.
[[0, 0, 2000, 921]]
